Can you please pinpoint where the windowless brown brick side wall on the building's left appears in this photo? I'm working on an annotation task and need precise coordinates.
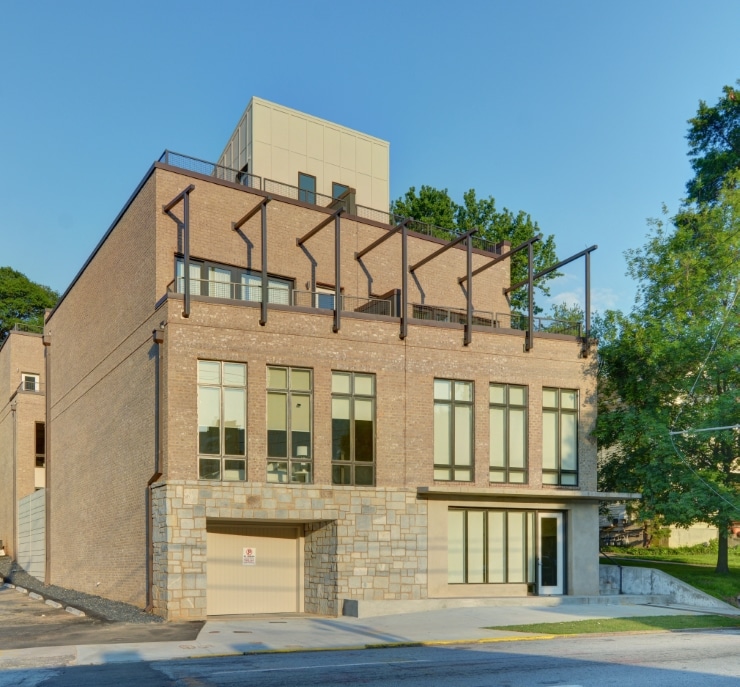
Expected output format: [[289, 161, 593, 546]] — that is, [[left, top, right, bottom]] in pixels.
[[46, 177, 158, 605]]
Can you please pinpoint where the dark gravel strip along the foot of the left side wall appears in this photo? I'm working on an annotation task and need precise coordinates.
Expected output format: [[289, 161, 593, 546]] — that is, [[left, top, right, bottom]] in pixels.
[[0, 556, 164, 623]]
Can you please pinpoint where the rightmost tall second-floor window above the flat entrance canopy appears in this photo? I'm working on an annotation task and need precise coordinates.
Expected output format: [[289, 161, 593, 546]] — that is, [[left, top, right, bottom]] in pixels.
[[542, 389, 578, 486]]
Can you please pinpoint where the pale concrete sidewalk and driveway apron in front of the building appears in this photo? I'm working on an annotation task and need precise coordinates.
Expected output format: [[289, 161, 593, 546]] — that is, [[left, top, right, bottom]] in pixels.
[[0, 603, 740, 669]]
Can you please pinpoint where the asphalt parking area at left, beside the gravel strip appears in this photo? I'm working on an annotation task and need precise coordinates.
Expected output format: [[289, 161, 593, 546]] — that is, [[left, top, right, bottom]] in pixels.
[[0, 588, 203, 650]]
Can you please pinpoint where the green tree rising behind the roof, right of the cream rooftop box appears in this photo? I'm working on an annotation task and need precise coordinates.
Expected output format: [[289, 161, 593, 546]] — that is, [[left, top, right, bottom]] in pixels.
[[391, 186, 558, 312]]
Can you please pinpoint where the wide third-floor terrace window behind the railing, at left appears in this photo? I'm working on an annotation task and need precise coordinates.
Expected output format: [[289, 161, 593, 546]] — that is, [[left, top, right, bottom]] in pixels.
[[176, 258, 293, 305]]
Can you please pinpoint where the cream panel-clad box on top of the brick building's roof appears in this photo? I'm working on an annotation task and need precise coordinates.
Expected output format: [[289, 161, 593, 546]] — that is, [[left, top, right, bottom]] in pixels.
[[218, 98, 390, 211]]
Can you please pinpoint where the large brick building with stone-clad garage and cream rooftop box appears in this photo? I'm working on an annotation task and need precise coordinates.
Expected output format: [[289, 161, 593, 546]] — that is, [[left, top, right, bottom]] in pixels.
[[39, 100, 624, 619]]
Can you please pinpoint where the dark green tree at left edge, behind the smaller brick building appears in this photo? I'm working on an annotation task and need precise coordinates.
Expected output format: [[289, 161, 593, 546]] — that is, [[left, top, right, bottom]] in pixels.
[[0, 267, 59, 342]]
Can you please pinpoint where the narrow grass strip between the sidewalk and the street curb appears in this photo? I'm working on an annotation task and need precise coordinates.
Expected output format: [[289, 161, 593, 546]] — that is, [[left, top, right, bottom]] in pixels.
[[486, 615, 740, 635]]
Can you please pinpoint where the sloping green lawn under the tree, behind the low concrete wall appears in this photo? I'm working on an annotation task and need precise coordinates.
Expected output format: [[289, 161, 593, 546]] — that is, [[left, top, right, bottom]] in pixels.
[[601, 547, 740, 605]]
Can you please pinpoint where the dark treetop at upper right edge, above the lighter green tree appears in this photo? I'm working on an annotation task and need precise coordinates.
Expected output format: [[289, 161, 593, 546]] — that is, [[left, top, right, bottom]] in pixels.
[[686, 79, 740, 203]]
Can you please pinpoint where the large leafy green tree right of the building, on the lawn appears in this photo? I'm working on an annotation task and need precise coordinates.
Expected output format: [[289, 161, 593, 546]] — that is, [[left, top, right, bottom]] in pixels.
[[596, 174, 740, 573]]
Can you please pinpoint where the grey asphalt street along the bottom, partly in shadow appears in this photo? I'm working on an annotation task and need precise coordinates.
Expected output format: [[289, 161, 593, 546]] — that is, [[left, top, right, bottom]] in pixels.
[[0, 631, 740, 687]]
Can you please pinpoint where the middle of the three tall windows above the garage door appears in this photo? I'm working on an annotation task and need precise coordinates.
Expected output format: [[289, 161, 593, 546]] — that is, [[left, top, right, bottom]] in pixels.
[[267, 367, 313, 483]]
